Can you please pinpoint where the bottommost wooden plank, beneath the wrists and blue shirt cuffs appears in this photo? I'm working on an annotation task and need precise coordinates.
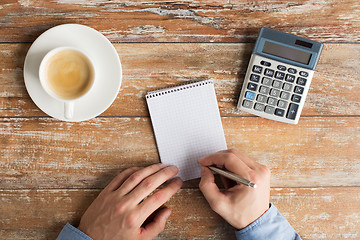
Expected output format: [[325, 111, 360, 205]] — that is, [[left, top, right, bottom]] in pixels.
[[0, 187, 360, 240]]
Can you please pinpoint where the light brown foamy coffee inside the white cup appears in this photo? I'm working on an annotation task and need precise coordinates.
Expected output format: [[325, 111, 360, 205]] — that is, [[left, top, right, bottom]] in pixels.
[[45, 49, 94, 100]]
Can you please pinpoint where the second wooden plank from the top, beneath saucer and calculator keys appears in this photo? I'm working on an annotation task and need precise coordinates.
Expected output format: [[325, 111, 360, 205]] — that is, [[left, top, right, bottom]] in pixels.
[[0, 43, 360, 117]]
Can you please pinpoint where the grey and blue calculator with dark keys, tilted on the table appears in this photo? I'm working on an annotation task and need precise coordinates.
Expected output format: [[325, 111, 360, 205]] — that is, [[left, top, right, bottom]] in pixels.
[[237, 27, 323, 124]]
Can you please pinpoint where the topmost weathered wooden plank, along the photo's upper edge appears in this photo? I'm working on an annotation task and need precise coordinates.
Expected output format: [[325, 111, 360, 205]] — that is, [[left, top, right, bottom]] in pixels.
[[0, 0, 360, 42]]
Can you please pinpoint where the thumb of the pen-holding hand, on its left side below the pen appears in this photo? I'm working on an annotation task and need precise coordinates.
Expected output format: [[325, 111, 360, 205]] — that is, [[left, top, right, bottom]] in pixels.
[[199, 167, 227, 212]]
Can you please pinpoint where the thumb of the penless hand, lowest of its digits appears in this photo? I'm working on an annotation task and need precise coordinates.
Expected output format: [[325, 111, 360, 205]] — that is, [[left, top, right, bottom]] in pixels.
[[141, 208, 171, 239]]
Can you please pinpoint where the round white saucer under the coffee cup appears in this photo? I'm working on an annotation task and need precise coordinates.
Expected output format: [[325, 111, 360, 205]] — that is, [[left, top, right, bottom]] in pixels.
[[24, 24, 122, 122]]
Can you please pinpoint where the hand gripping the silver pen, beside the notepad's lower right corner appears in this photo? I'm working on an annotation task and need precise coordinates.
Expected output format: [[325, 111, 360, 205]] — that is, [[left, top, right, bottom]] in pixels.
[[199, 149, 270, 229]]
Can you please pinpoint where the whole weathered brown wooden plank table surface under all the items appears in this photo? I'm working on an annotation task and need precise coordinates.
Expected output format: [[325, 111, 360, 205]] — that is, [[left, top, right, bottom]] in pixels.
[[0, 0, 360, 239]]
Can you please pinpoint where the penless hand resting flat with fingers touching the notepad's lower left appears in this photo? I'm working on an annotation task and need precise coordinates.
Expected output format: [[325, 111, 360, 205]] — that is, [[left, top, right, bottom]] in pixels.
[[79, 164, 182, 240]]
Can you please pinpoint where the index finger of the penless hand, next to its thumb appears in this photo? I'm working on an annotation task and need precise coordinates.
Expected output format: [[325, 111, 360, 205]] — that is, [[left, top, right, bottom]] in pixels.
[[140, 178, 183, 221]]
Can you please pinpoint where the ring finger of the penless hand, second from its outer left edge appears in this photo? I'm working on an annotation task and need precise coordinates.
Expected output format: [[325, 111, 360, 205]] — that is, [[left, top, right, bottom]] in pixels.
[[117, 163, 166, 195]]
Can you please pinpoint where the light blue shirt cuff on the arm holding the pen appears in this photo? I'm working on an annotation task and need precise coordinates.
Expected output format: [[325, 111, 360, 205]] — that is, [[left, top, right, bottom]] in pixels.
[[235, 204, 301, 240]]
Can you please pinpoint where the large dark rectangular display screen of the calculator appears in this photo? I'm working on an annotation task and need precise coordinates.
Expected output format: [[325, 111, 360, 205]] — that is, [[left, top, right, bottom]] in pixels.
[[262, 41, 311, 64]]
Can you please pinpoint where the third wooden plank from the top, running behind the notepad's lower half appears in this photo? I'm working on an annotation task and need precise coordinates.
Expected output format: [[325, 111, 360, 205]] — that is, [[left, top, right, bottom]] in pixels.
[[0, 117, 360, 189]]
